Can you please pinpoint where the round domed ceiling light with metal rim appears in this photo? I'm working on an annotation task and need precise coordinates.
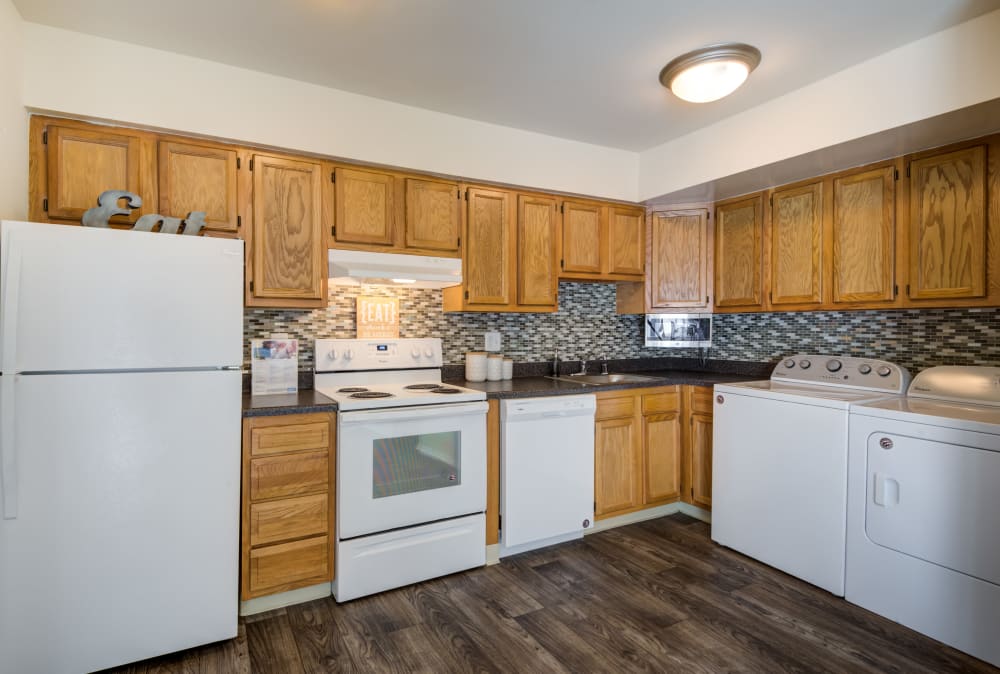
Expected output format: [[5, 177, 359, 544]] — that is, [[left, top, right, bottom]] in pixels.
[[660, 42, 760, 103]]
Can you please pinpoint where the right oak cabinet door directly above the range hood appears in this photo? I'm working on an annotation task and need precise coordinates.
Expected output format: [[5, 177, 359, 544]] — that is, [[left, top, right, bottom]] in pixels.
[[406, 178, 462, 252]]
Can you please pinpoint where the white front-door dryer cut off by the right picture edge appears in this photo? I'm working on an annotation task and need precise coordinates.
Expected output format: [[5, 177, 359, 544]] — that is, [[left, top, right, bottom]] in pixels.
[[846, 366, 1000, 665]]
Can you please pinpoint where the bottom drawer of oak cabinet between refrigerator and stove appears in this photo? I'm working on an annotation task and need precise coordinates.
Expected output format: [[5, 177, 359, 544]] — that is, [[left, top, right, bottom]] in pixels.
[[250, 536, 332, 595]]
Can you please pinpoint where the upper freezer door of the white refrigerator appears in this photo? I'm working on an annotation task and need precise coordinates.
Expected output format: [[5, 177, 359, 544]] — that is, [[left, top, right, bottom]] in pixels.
[[0, 222, 243, 372]]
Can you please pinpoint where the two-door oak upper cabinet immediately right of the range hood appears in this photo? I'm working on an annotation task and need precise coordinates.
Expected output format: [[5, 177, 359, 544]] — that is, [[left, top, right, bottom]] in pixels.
[[443, 187, 558, 312]]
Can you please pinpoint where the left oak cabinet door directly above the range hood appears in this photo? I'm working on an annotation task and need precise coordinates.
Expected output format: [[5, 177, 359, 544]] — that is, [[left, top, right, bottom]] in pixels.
[[334, 167, 396, 246]]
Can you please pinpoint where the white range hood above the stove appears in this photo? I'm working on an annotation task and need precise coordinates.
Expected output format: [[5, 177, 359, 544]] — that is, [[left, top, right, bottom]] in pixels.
[[330, 248, 462, 288]]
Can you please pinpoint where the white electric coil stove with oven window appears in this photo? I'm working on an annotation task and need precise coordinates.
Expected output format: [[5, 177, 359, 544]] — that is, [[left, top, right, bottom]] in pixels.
[[314, 339, 488, 601]]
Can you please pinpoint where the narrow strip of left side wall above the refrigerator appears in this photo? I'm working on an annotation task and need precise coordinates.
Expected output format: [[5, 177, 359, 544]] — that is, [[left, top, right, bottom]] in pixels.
[[0, 0, 28, 220]]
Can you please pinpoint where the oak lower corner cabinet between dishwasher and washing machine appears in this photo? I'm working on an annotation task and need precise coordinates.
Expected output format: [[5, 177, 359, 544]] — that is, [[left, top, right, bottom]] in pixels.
[[594, 386, 712, 519]]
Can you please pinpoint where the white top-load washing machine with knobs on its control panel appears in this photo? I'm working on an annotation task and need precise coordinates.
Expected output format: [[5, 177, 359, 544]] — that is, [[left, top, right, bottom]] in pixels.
[[712, 354, 910, 596]]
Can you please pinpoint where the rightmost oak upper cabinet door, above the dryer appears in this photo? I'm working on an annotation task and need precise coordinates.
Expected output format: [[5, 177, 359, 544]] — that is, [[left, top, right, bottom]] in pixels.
[[909, 145, 986, 299]]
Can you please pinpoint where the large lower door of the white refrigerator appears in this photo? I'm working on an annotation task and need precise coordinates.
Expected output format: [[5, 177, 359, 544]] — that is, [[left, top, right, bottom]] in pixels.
[[0, 371, 241, 674]]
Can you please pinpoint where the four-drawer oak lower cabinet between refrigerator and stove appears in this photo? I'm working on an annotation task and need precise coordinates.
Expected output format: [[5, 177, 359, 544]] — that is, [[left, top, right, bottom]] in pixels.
[[240, 412, 336, 600]]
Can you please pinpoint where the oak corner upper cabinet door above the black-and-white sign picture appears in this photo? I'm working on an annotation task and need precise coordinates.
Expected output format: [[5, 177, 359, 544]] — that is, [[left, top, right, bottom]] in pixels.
[[649, 210, 708, 309]]
